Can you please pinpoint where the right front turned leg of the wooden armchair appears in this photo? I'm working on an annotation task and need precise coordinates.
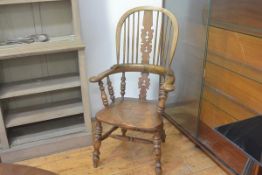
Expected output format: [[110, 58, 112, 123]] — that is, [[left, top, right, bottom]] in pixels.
[[153, 132, 162, 175]]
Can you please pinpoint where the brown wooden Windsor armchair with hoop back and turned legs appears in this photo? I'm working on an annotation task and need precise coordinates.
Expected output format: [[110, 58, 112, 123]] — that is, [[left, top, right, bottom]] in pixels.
[[90, 6, 178, 175]]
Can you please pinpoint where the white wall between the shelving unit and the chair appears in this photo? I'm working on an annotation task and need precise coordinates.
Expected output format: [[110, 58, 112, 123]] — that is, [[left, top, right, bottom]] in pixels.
[[79, 0, 162, 116]]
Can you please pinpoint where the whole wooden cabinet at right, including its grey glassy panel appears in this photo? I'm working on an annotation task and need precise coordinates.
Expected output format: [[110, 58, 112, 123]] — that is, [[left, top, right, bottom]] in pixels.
[[165, 0, 262, 174]]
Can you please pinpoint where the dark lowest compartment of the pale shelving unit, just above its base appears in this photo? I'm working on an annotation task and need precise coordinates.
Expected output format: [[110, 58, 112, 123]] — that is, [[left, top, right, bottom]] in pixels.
[[9, 116, 86, 147]]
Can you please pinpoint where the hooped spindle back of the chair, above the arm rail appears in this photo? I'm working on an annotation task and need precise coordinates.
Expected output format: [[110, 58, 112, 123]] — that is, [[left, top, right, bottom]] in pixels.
[[116, 6, 178, 67]]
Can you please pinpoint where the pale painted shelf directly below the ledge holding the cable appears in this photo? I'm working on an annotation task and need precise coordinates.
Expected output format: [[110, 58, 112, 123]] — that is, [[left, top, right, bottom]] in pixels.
[[0, 74, 81, 99]]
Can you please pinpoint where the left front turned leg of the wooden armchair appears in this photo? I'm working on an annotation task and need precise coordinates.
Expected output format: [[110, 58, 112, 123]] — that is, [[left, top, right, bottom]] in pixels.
[[93, 121, 102, 168]]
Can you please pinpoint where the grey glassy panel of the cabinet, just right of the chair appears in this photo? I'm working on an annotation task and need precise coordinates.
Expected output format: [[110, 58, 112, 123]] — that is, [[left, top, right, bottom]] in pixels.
[[164, 0, 209, 136]]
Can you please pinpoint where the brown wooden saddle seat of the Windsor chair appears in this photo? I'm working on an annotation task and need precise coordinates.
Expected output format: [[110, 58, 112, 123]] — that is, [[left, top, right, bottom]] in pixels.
[[96, 98, 162, 132]]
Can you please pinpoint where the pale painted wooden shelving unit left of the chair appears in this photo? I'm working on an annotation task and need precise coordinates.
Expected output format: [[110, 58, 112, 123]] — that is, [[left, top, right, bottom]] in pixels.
[[0, 0, 92, 162]]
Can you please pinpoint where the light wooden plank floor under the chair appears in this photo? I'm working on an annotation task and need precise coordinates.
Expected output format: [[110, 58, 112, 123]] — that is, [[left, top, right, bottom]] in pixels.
[[18, 121, 226, 175]]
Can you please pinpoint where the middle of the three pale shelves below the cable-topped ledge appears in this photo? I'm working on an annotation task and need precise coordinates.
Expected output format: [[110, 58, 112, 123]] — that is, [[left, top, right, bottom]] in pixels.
[[5, 99, 83, 128]]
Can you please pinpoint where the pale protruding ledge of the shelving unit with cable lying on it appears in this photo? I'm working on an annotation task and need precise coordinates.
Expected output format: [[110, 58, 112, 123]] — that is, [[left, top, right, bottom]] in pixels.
[[0, 35, 85, 60]]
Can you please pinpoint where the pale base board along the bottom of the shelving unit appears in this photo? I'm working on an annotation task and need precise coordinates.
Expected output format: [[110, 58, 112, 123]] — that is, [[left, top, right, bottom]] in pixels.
[[0, 132, 92, 163]]
